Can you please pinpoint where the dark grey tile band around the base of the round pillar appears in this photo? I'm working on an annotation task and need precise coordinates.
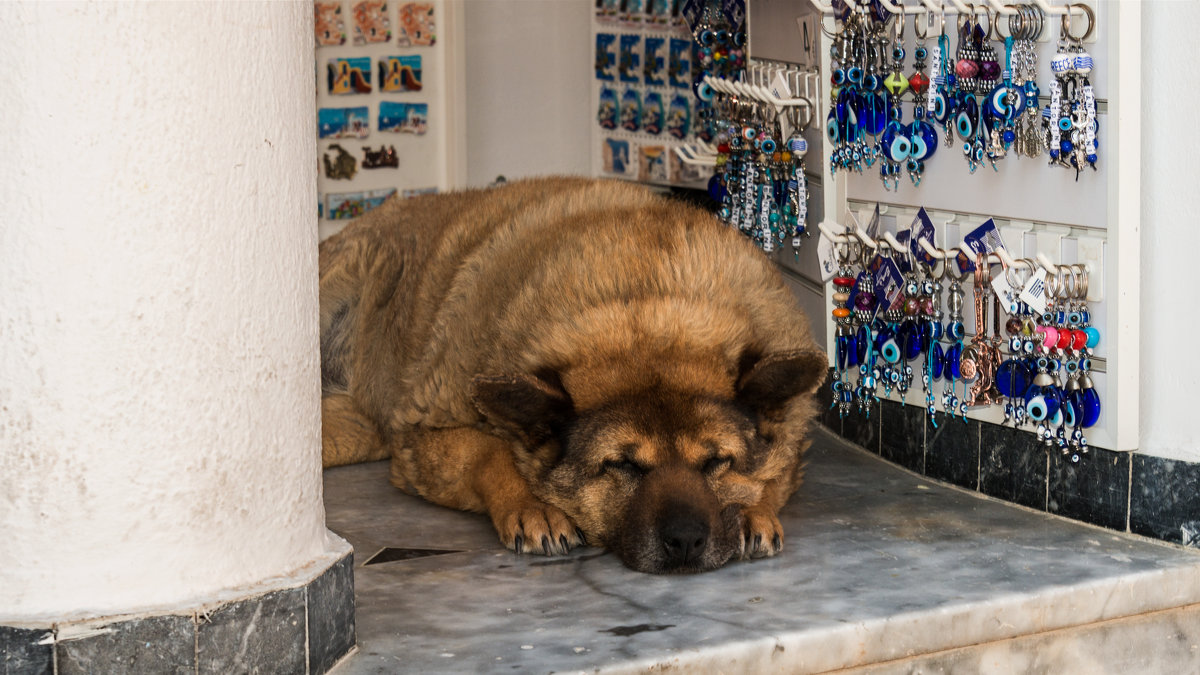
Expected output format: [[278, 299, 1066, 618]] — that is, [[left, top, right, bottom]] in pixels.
[[0, 551, 355, 675]]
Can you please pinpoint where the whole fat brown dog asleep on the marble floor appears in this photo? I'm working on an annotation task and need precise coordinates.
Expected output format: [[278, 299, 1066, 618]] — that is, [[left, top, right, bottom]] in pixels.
[[320, 179, 826, 573]]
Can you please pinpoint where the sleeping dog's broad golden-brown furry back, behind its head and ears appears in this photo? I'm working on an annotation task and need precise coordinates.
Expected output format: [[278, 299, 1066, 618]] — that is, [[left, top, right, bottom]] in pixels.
[[320, 179, 812, 466]]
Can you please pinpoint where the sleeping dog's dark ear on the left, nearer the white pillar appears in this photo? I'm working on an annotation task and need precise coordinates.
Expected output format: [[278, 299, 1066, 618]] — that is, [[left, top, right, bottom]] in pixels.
[[470, 375, 575, 447]]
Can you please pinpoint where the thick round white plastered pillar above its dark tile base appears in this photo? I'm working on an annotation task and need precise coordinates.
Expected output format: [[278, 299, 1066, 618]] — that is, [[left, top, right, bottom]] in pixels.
[[0, 2, 344, 621]]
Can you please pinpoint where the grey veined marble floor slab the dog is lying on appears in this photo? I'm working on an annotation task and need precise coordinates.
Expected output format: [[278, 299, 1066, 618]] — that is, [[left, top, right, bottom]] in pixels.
[[325, 430, 1200, 675]]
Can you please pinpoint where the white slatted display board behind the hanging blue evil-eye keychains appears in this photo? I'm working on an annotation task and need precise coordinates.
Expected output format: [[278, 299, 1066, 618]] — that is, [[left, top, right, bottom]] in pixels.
[[749, 0, 1140, 450]]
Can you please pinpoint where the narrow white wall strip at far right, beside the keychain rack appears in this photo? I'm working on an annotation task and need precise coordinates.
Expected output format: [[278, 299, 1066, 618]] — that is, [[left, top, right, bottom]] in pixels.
[[1139, 0, 1200, 461]]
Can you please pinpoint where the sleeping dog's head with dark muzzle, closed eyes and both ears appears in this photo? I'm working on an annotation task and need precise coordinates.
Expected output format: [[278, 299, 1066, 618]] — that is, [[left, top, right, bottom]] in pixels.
[[474, 351, 826, 573]]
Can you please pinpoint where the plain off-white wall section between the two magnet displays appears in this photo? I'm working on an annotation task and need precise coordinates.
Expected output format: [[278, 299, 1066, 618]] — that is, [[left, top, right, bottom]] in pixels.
[[464, 0, 595, 187]]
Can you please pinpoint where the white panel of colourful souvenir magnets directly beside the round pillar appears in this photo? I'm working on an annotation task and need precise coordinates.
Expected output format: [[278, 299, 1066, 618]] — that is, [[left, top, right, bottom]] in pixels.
[[313, 0, 448, 221]]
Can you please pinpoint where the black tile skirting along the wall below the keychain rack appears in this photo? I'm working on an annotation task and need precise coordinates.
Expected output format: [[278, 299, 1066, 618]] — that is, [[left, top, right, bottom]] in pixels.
[[864, 400, 1200, 548]]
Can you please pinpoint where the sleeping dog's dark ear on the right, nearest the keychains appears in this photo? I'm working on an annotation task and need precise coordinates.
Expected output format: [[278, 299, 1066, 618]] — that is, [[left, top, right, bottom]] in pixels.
[[737, 348, 829, 417]]
